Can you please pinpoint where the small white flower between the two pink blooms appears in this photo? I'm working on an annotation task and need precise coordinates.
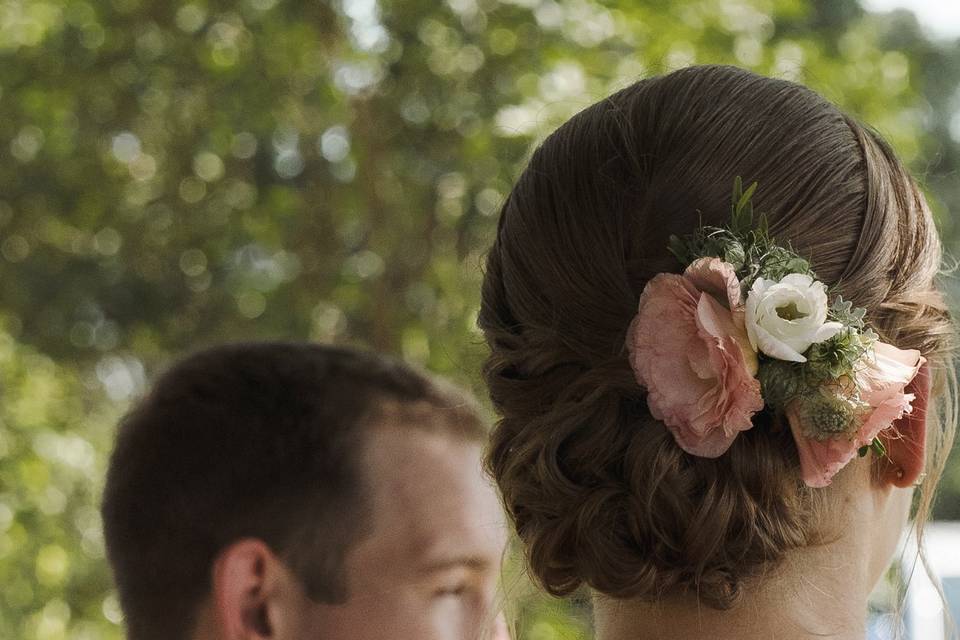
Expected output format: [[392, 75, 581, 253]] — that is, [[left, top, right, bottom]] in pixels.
[[746, 273, 843, 362]]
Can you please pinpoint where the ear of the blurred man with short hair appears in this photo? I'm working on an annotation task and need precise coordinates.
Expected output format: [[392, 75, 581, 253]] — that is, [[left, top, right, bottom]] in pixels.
[[212, 538, 304, 640]]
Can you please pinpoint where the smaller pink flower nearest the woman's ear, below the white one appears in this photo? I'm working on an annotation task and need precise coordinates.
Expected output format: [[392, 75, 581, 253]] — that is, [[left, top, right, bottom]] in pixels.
[[786, 342, 926, 487]]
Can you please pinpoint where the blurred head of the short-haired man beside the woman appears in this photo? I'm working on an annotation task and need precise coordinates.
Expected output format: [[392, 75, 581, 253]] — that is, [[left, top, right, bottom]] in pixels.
[[103, 343, 503, 640]]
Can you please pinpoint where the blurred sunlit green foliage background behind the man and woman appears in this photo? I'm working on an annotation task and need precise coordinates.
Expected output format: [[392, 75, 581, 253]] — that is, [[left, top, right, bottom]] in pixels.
[[0, 0, 960, 640]]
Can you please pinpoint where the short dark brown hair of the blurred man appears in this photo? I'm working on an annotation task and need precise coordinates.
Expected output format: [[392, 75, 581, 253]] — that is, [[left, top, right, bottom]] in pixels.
[[103, 343, 485, 640]]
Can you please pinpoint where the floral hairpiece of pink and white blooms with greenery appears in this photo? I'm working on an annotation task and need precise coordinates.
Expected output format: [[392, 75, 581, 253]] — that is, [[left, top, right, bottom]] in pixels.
[[626, 177, 925, 487]]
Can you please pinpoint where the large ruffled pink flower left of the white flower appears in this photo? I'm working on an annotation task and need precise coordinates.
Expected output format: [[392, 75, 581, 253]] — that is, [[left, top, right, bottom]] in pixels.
[[626, 258, 763, 458]]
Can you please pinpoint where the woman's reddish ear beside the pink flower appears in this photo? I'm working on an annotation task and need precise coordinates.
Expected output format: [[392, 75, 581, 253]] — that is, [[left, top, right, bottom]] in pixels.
[[878, 362, 932, 488]]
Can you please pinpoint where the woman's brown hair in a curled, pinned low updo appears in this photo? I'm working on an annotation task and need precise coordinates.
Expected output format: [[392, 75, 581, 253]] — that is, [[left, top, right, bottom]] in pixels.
[[479, 66, 953, 608]]
